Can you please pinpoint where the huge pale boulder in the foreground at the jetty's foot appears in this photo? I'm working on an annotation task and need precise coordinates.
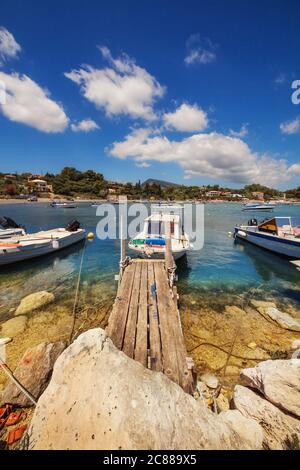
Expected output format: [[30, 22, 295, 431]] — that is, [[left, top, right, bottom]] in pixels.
[[25, 328, 263, 450]]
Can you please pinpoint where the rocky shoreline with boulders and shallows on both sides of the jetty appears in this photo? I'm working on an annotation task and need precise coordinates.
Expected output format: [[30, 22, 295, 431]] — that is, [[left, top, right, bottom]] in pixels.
[[0, 291, 300, 449]]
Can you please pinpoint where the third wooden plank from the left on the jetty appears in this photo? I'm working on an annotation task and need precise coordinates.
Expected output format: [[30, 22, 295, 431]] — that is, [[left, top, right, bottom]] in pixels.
[[134, 263, 148, 367]]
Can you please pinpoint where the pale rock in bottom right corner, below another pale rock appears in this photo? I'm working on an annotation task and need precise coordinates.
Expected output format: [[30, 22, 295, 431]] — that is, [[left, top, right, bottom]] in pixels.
[[233, 385, 300, 450]]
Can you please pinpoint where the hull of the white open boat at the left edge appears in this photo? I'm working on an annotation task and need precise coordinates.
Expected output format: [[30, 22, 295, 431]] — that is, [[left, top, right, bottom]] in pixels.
[[0, 229, 85, 266]]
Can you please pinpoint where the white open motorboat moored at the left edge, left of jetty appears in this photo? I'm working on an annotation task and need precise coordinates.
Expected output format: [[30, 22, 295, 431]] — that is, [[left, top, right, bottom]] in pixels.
[[0, 221, 85, 266]]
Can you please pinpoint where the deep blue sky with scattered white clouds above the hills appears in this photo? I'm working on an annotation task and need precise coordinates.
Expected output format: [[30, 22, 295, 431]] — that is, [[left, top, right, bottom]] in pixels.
[[0, 0, 300, 188]]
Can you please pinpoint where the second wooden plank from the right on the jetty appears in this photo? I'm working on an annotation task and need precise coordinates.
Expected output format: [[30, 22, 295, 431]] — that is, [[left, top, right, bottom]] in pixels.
[[154, 264, 179, 383]]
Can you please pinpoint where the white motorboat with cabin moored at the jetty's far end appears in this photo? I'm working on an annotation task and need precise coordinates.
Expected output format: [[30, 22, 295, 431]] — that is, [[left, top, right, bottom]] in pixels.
[[128, 204, 191, 259]]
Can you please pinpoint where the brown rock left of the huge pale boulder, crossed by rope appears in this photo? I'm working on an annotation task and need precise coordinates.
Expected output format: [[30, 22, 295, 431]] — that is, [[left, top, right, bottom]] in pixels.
[[1, 342, 66, 406]]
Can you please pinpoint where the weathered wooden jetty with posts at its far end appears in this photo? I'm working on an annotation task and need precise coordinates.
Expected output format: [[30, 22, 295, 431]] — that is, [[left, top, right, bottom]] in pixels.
[[107, 240, 196, 393]]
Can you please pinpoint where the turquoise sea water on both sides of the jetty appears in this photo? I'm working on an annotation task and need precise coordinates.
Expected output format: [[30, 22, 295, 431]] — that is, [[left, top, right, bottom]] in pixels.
[[0, 203, 300, 321]]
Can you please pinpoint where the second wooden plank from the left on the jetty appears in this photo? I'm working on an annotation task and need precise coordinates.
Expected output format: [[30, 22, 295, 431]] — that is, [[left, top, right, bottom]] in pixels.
[[122, 263, 142, 358]]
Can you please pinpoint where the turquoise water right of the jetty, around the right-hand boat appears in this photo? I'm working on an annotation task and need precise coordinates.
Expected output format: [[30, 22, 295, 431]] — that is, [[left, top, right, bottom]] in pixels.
[[180, 204, 300, 305]]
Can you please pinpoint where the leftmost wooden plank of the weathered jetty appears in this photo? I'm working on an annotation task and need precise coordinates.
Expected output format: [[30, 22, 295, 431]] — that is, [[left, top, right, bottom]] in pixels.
[[107, 263, 136, 349]]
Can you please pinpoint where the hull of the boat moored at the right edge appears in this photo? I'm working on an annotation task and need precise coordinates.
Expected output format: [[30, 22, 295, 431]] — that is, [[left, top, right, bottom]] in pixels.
[[235, 227, 300, 259]]
